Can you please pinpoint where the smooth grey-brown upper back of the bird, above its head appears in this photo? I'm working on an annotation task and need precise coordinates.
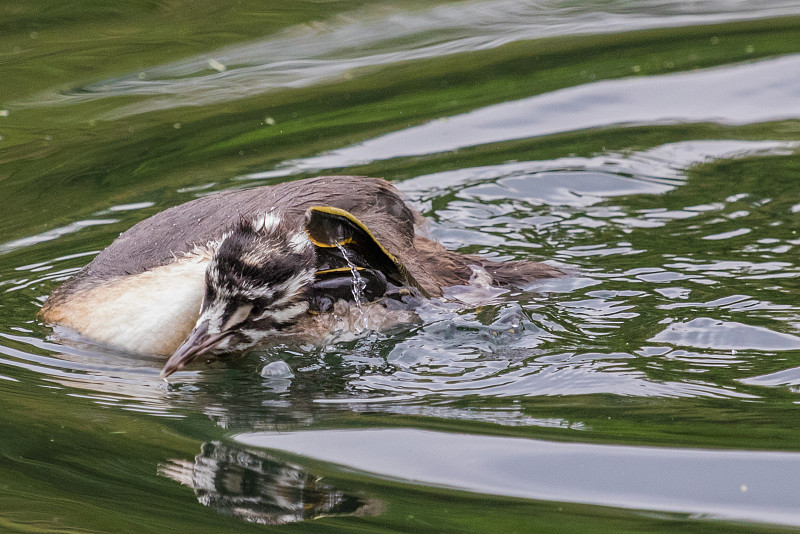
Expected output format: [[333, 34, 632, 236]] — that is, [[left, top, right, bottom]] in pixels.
[[88, 176, 415, 278]]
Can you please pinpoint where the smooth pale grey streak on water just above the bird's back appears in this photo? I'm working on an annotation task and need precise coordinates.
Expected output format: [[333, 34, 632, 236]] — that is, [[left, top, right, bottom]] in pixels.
[[248, 55, 800, 178]]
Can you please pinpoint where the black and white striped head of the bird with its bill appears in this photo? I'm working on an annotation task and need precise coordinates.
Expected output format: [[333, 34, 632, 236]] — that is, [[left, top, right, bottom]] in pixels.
[[161, 212, 315, 377]]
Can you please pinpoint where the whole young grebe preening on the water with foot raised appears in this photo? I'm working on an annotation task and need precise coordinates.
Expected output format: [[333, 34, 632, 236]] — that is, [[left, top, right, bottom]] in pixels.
[[40, 176, 561, 376]]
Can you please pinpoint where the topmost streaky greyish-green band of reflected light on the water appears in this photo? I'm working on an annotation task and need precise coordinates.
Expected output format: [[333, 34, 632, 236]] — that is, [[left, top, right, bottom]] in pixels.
[[34, 0, 798, 118]]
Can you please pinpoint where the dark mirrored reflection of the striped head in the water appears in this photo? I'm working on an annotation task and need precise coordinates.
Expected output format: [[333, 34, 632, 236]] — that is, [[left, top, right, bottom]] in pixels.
[[158, 442, 381, 525]]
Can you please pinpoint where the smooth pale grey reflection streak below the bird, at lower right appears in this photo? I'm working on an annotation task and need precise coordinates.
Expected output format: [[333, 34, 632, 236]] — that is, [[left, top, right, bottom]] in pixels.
[[236, 428, 800, 526]]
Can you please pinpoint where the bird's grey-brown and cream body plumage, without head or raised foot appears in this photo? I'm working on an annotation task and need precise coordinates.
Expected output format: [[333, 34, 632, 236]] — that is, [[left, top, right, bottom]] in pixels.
[[40, 176, 562, 376]]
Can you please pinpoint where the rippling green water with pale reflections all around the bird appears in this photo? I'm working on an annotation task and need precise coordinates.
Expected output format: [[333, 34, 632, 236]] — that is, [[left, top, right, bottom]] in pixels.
[[0, 0, 800, 533]]
